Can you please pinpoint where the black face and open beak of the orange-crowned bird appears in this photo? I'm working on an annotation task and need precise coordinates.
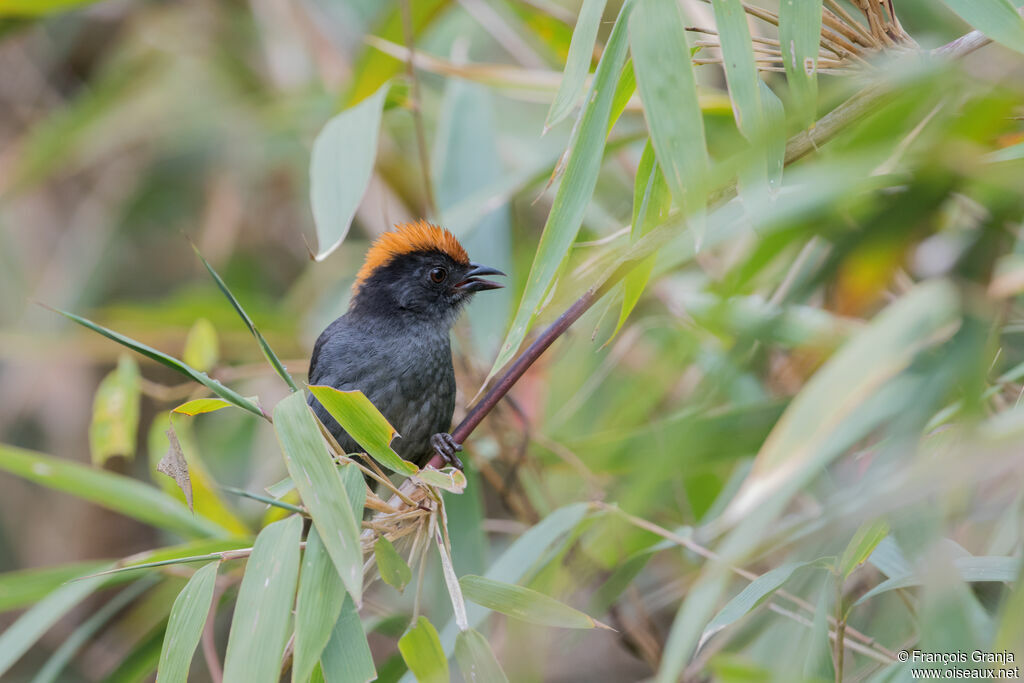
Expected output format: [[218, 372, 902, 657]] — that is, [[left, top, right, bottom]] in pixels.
[[352, 250, 505, 325]]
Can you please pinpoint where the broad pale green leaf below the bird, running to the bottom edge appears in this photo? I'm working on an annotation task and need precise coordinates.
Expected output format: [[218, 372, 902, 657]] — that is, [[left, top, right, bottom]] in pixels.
[[224, 518, 302, 683]]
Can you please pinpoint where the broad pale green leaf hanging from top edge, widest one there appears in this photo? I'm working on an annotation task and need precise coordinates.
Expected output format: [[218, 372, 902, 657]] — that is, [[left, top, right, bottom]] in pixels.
[[630, 0, 708, 216]]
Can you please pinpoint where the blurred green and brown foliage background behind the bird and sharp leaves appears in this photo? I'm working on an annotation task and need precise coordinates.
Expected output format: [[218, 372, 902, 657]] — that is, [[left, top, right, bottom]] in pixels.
[[6, 0, 1024, 681]]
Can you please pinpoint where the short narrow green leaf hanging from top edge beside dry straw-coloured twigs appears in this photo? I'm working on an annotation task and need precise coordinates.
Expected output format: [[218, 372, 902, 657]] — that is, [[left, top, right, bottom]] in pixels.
[[778, 0, 821, 125]]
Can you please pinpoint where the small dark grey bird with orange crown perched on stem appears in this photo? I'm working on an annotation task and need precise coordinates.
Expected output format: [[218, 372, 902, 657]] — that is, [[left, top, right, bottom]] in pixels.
[[307, 220, 505, 469]]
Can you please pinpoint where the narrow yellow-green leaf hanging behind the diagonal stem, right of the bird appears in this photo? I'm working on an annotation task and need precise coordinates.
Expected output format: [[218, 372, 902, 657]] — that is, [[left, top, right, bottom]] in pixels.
[[611, 138, 672, 337]]
